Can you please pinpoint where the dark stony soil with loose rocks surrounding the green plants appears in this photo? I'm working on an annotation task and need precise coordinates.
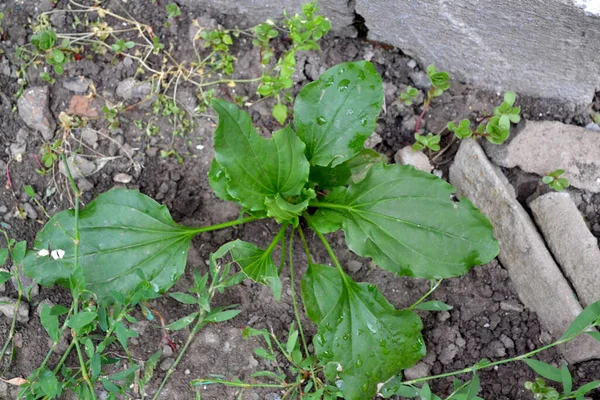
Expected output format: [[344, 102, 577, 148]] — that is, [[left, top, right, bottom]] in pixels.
[[0, 0, 600, 400]]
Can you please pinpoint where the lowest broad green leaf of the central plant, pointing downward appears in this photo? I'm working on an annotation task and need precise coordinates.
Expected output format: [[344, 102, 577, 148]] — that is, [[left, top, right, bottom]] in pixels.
[[302, 265, 425, 400]]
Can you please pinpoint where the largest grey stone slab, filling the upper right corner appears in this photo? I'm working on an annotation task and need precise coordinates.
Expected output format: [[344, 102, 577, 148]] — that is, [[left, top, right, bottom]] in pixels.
[[356, 0, 600, 105]]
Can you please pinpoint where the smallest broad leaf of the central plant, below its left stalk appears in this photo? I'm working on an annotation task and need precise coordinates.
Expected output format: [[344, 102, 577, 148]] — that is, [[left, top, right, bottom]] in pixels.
[[229, 240, 277, 284]]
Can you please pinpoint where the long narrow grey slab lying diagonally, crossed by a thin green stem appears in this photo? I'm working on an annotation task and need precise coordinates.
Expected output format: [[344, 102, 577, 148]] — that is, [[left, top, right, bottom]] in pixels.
[[450, 139, 600, 363]]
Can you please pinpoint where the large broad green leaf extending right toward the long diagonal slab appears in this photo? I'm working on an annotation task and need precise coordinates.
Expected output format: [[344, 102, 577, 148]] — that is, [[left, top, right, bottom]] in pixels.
[[311, 164, 498, 279]]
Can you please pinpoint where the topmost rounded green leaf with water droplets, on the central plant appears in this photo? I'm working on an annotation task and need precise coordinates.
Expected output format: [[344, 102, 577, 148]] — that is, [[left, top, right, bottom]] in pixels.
[[294, 61, 383, 167]]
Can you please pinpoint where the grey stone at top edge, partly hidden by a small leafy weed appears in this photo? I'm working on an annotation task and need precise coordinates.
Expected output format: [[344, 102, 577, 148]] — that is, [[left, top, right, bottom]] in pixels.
[[179, 0, 356, 34]]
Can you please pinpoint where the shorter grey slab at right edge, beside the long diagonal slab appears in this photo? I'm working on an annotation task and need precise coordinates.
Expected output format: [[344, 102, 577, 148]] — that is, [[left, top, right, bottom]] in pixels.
[[529, 192, 600, 307]]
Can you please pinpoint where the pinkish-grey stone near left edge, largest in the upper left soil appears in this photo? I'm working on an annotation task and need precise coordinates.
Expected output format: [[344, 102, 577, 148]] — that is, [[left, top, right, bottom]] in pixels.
[[17, 86, 56, 141]]
